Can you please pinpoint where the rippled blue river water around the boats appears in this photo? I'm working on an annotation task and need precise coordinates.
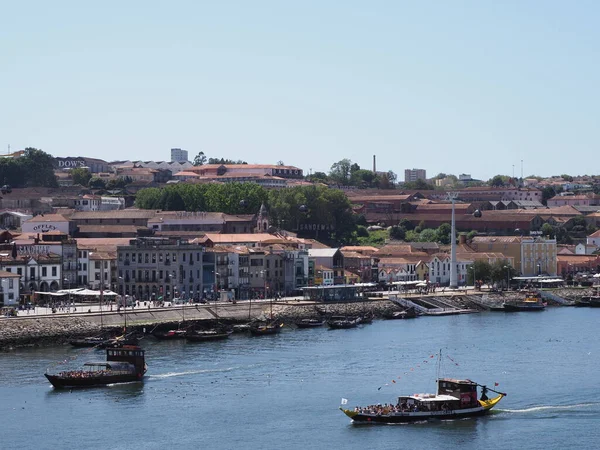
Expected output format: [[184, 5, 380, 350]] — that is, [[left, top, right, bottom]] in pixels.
[[0, 308, 600, 449]]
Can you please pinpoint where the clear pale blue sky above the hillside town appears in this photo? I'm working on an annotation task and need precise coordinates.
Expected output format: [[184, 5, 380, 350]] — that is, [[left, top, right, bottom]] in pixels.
[[0, 0, 600, 181]]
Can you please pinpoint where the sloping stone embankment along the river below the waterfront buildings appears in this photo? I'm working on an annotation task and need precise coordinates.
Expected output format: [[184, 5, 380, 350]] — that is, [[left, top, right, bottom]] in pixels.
[[0, 288, 592, 350]]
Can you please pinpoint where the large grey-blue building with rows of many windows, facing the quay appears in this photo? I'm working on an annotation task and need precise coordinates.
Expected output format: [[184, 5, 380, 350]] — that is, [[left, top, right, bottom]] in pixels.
[[117, 238, 216, 300]]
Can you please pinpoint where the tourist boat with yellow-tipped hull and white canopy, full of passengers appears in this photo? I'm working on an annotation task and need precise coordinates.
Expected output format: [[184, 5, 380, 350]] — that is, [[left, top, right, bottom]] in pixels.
[[340, 378, 506, 423]]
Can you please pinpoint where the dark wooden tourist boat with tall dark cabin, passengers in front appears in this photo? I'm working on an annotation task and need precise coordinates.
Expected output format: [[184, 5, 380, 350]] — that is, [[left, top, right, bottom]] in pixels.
[[44, 345, 147, 388]]
